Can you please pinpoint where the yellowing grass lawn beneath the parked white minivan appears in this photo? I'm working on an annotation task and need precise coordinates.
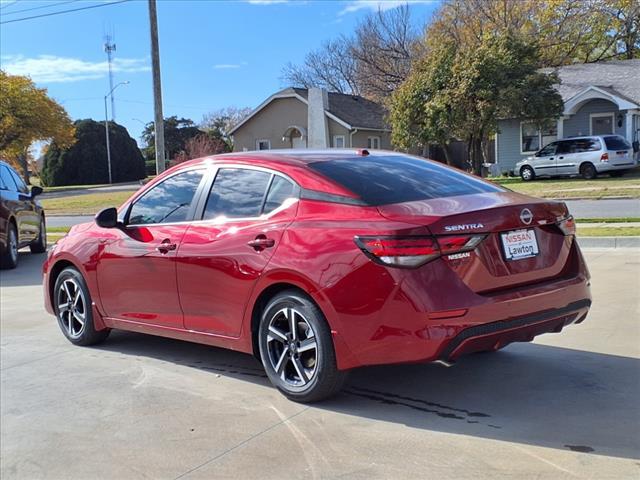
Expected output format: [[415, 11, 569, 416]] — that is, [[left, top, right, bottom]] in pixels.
[[489, 169, 640, 199]]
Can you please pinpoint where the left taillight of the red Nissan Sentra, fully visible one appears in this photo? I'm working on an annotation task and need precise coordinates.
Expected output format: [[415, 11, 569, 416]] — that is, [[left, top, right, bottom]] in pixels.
[[354, 235, 486, 268]]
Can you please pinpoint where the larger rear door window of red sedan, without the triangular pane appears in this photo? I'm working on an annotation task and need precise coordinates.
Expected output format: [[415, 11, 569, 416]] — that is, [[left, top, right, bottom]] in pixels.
[[204, 168, 271, 220]]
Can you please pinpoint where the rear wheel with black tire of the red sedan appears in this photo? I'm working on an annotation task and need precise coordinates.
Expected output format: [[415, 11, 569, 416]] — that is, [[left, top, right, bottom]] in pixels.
[[258, 290, 347, 403]]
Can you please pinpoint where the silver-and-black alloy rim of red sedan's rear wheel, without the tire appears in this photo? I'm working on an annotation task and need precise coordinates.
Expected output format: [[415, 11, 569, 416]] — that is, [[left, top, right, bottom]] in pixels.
[[267, 307, 319, 387]]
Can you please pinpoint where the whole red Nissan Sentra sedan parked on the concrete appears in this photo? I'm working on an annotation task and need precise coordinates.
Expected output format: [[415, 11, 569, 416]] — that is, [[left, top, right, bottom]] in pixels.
[[44, 150, 591, 402]]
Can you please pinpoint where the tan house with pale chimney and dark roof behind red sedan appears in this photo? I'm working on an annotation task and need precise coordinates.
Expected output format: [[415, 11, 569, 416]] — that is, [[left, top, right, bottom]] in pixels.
[[230, 88, 391, 151]]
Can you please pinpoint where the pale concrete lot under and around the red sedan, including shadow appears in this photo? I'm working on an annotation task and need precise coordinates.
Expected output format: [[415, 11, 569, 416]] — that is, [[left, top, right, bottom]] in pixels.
[[0, 249, 640, 480]]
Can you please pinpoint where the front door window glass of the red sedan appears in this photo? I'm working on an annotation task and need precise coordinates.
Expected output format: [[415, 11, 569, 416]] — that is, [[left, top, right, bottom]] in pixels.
[[128, 170, 204, 225]]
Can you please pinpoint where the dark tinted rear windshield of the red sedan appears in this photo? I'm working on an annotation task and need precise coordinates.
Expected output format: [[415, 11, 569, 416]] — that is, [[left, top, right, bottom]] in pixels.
[[309, 155, 505, 205]]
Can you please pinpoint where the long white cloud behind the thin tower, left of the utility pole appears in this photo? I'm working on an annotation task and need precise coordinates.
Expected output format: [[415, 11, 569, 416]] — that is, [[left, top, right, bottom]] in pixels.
[[1, 55, 151, 83]]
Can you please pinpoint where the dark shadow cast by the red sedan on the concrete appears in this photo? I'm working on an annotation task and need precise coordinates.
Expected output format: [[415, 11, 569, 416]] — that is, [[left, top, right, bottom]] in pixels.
[[98, 332, 640, 459]]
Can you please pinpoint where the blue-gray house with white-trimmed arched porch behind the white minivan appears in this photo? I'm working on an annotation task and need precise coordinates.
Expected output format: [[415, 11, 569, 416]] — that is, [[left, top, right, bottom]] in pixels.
[[490, 59, 640, 174]]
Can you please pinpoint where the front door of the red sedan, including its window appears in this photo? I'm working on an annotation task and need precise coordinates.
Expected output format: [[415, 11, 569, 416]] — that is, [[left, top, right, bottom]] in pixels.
[[96, 169, 205, 328]]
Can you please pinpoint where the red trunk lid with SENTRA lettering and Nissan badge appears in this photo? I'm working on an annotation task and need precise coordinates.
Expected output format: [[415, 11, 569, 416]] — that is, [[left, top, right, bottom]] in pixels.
[[378, 192, 572, 293]]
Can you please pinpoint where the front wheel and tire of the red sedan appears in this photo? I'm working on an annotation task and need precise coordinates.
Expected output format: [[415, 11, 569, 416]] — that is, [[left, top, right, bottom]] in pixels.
[[52, 267, 110, 346]]
